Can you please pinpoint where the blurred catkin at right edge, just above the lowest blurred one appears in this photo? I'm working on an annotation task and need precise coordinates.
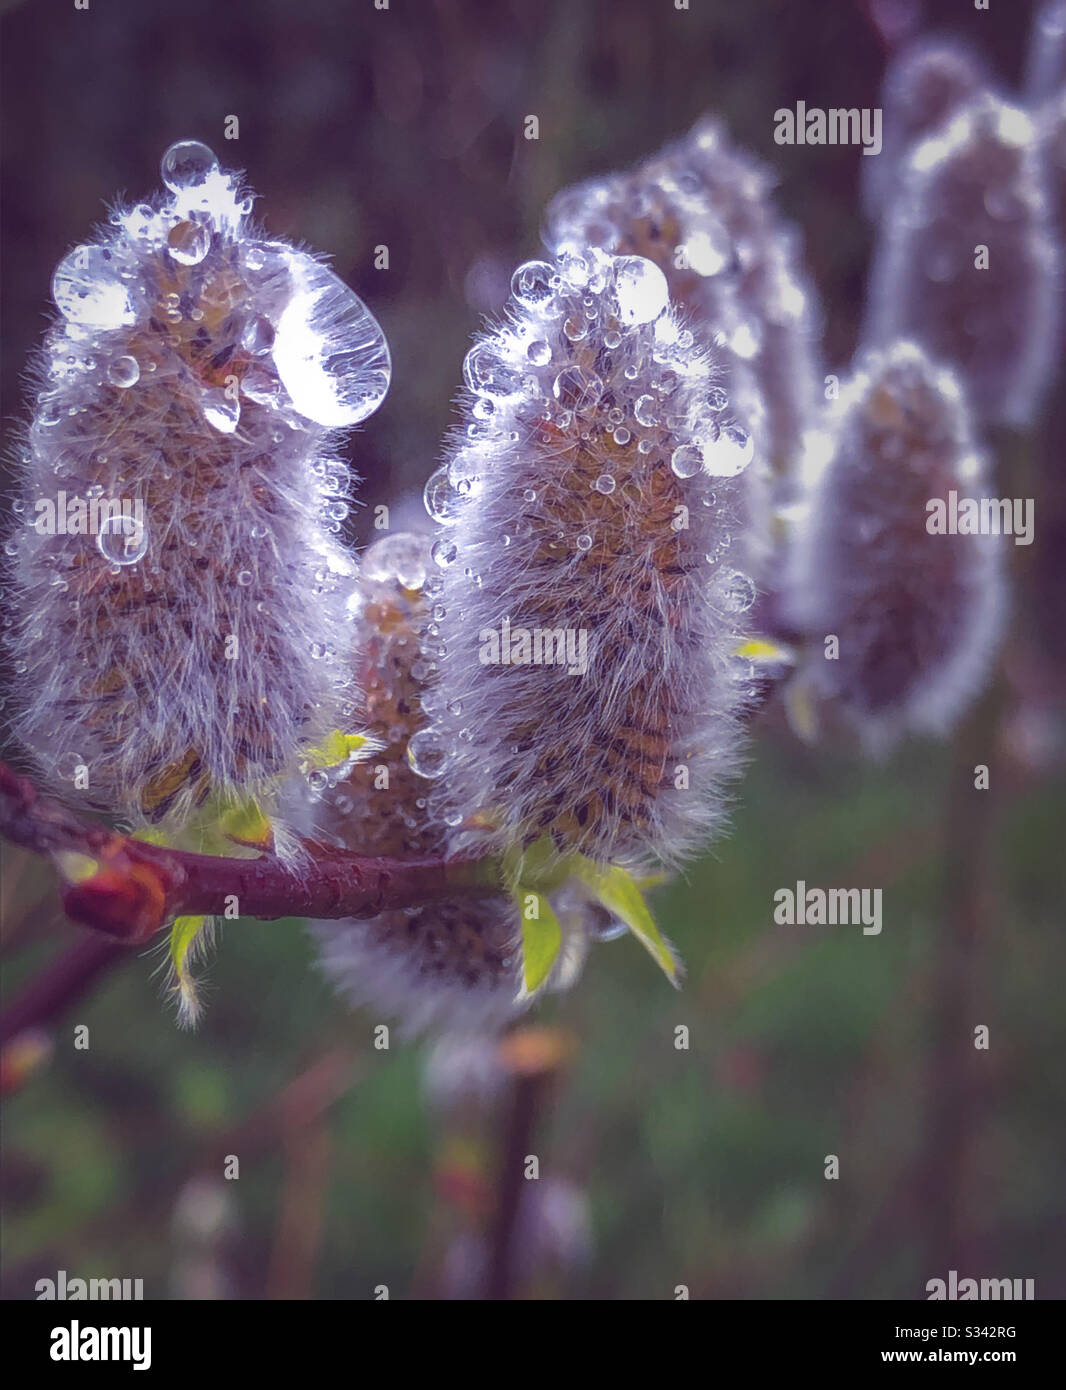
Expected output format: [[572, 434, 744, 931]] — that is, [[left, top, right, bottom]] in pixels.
[[864, 93, 1060, 425]]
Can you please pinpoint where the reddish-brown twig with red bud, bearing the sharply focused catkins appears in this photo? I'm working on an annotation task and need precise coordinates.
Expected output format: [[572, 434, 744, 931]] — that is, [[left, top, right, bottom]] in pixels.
[[0, 763, 499, 945]]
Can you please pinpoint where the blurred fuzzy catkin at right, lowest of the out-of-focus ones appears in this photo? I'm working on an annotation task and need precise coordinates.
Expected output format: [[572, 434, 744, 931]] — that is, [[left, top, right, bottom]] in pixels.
[[785, 342, 1005, 753]]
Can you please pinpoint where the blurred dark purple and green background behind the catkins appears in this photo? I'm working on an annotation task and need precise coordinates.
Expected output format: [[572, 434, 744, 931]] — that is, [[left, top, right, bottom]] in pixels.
[[0, 0, 1066, 1298]]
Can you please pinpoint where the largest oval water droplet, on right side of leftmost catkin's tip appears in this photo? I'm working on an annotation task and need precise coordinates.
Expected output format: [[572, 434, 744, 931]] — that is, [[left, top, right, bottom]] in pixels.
[[274, 253, 392, 428]]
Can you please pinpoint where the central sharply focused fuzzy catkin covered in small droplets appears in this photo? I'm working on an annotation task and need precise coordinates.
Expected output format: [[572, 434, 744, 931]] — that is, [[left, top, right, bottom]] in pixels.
[[422, 249, 755, 863]]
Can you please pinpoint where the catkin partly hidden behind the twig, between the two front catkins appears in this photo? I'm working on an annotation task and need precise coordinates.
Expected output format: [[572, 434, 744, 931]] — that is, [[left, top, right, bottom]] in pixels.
[[313, 534, 591, 1031]]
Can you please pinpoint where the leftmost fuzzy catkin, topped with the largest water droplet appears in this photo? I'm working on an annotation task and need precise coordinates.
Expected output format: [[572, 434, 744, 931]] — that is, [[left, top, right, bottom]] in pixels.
[[7, 142, 391, 826]]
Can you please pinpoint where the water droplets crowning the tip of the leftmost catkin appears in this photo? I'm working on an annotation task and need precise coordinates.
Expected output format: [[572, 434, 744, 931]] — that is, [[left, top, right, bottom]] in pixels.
[[51, 140, 392, 450]]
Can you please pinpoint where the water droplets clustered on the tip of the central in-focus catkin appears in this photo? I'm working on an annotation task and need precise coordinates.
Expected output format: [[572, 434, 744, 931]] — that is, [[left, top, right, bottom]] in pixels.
[[425, 247, 755, 569]]
